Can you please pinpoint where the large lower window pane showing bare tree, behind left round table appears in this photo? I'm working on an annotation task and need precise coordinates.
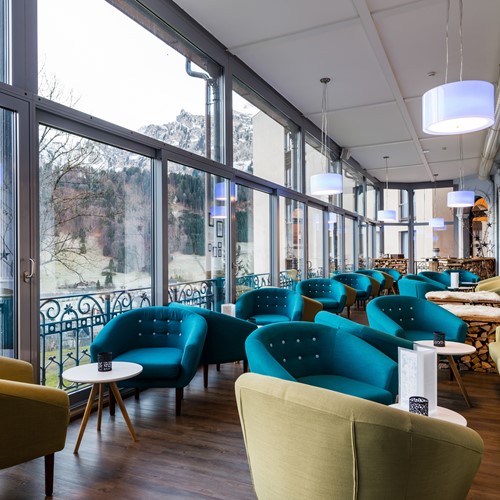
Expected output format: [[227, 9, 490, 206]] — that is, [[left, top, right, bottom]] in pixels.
[[39, 125, 154, 386]]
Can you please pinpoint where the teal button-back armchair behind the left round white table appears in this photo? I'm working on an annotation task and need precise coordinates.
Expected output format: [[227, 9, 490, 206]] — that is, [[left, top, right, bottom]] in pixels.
[[90, 306, 207, 415]]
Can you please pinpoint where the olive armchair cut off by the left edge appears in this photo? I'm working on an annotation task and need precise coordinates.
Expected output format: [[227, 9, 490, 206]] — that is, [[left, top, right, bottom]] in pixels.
[[0, 357, 69, 496]]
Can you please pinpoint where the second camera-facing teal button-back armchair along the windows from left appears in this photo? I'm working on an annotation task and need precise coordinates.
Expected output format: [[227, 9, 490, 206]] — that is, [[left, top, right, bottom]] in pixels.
[[236, 287, 304, 326]]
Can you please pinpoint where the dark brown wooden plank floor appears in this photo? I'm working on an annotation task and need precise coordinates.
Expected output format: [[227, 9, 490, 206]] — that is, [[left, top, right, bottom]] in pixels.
[[0, 313, 500, 500]]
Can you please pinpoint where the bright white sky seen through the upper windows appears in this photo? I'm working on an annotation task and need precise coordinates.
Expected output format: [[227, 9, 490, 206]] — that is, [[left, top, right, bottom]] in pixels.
[[38, 0, 251, 130]]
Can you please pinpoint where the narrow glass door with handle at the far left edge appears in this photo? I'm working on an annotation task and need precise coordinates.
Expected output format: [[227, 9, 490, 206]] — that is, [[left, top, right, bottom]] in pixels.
[[0, 94, 32, 361]]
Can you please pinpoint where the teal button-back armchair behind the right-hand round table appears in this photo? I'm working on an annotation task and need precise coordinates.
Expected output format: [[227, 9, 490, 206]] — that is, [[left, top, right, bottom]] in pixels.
[[366, 295, 467, 342]]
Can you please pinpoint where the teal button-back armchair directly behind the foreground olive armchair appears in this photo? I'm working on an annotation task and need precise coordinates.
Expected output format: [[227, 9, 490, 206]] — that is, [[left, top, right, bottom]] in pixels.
[[245, 321, 397, 404]]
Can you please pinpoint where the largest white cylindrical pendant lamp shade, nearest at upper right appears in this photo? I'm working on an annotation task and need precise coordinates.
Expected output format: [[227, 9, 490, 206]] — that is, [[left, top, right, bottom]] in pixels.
[[422, 80, 495, 135]]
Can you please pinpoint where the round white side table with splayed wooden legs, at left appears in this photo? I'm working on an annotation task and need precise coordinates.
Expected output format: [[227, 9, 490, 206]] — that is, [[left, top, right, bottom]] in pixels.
[[62, 361, 142, 453]]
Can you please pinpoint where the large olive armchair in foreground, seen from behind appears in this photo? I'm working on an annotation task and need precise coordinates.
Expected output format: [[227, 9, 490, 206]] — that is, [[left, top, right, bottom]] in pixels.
[[236, 373, 483, 500]]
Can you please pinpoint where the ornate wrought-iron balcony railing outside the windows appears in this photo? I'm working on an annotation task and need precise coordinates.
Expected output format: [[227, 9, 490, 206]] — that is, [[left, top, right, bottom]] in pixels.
[[40, 271, 297, 392]]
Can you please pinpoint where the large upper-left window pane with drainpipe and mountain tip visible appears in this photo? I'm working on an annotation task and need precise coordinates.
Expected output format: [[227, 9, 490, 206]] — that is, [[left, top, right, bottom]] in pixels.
[[38, 0, 222, 160]]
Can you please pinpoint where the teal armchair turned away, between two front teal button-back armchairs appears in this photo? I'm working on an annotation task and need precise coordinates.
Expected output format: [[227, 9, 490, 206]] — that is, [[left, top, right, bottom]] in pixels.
[[168, 302, 257, 387]]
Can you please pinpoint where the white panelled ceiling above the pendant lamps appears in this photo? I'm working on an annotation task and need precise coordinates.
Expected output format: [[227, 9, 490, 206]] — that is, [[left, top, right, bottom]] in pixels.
[[175, 0, 500, 182]]
